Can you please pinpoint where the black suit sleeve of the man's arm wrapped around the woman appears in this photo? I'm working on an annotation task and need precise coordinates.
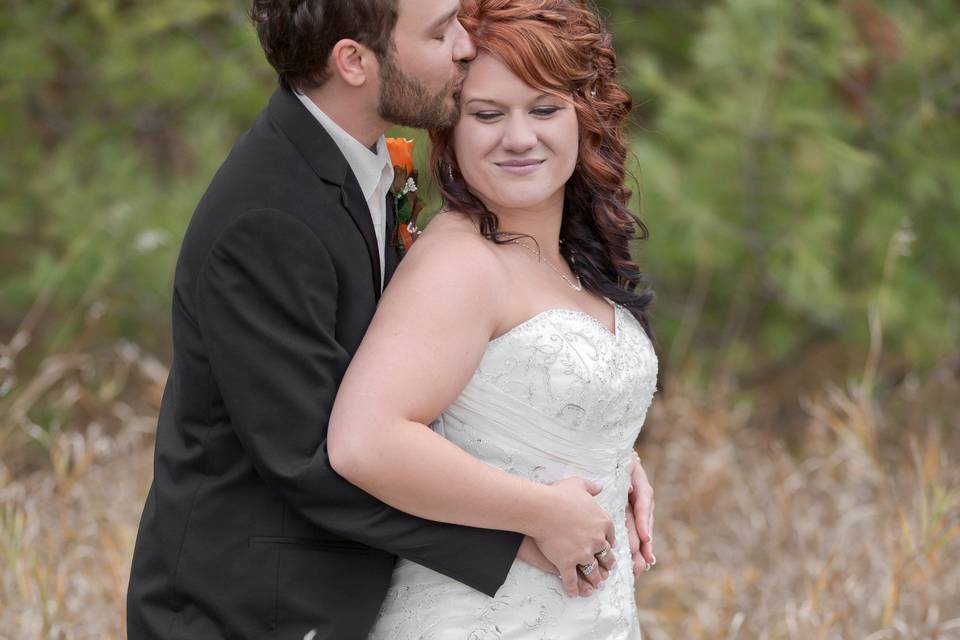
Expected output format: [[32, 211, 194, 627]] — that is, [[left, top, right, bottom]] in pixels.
[[195, 210, 523, 596]]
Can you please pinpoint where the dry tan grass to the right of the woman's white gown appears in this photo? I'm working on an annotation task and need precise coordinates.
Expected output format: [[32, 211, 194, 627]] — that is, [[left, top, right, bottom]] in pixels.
[[637, 380, 960, 640]]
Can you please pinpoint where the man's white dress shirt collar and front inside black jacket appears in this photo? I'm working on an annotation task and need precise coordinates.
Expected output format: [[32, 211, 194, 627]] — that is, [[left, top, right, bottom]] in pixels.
[[296, 93, 393, 293]]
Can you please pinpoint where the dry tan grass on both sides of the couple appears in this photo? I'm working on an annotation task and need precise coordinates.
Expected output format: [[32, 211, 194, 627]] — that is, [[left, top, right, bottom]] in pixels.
[[0, 358, 960, 640]]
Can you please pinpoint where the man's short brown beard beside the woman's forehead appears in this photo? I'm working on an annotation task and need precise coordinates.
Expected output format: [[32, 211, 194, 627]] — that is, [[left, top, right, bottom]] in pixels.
[[377, 54, 466, 129]]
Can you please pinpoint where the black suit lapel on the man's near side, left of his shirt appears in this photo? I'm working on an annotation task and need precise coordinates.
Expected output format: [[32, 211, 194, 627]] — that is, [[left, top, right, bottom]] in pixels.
[[267, 89, 382, 300]]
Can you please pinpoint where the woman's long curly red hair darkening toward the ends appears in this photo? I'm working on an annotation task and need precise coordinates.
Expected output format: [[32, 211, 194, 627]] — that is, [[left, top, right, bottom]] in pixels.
[[430, 0, 653, 335]]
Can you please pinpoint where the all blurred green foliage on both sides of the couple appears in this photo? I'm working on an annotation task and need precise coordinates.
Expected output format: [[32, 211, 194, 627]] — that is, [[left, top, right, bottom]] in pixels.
[[0, 0, 960, 397]]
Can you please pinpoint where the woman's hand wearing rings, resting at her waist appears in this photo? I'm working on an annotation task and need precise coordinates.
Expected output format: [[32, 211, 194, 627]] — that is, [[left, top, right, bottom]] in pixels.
[[533, 477, 617, 597]]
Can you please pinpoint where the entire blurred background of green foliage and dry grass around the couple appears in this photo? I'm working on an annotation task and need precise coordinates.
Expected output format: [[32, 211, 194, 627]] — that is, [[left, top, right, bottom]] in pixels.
[[0, 0, 960, 640]]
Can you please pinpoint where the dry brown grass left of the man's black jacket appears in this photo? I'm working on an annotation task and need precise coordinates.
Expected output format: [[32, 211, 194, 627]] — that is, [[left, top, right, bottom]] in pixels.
[[0, 341, 166, 640]]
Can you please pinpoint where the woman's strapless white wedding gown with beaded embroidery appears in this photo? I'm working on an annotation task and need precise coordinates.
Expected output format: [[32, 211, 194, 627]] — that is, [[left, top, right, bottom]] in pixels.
[[369, 306, 657, 640]]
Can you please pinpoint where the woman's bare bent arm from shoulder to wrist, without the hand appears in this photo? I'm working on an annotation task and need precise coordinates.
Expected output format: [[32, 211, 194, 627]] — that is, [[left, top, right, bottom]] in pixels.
[[327, 221, 568, 538]]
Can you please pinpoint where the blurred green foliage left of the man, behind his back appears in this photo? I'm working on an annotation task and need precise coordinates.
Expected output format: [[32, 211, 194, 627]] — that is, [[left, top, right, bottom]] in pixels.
[[0, 0, 273, 370]]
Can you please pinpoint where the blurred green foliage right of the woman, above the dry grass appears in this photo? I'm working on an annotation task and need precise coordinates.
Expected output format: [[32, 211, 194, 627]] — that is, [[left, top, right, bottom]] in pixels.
[[613, 0, 960, 381]]
